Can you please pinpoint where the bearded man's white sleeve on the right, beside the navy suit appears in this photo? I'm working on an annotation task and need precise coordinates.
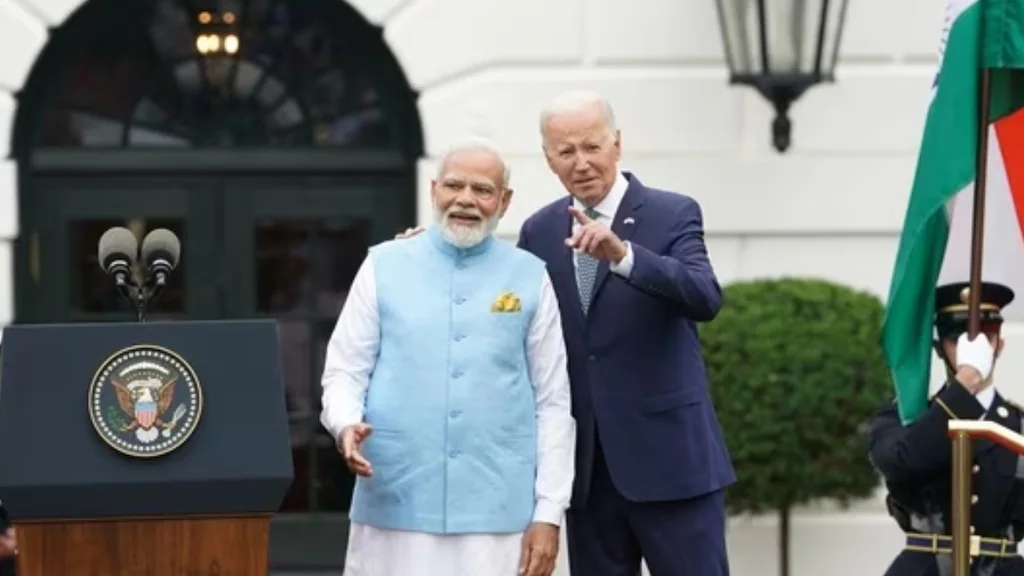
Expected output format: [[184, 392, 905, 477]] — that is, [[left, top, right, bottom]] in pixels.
[[526, 274, 575, 526]]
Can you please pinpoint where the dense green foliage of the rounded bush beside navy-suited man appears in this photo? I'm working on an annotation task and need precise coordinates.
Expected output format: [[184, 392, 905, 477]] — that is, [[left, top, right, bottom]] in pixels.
[[700, 279, 891, 513]]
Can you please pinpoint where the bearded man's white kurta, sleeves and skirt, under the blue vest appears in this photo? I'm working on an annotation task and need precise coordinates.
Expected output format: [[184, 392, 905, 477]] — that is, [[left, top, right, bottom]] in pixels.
[[321, 252, 575, 576]]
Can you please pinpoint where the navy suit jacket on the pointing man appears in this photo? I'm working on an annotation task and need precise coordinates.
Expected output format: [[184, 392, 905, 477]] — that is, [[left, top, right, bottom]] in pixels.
[[519, 172, 736, 506]]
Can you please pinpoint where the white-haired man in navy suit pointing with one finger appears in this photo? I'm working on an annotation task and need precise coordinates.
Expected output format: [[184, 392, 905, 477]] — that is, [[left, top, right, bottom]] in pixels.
[[519, 93, 736, 576]]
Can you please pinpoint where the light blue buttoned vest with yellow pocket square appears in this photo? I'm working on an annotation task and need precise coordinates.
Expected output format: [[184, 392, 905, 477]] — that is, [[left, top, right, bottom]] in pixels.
[[350, 227, 545, 534]]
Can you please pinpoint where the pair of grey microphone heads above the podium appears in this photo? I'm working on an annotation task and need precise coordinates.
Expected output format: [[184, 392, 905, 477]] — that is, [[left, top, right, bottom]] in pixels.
[[97, 228, 181, 289]]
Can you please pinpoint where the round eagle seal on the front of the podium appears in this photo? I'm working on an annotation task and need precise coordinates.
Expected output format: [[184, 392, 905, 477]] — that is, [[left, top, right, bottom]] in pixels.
[[89, 345, 203, 458]]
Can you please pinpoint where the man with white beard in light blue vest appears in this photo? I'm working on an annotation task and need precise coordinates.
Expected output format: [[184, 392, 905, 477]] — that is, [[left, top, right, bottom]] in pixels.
[[321, 136, 575, 576]]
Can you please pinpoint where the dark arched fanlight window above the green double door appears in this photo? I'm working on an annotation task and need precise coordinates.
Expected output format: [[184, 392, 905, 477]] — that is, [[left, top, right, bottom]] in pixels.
[[33, 0, 408, 150]]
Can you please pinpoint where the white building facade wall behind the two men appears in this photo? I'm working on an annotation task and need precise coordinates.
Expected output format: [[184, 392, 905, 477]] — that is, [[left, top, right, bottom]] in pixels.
[[0, 0, 1024, 576]]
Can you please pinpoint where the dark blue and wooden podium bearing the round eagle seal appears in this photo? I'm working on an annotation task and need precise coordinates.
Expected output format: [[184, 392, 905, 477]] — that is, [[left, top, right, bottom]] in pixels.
[[0, 321, 293, 576]]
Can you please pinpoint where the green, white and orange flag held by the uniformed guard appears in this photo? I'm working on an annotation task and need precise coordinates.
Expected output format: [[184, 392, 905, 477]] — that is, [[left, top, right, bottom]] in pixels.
[[882, 0, 1024, 422]]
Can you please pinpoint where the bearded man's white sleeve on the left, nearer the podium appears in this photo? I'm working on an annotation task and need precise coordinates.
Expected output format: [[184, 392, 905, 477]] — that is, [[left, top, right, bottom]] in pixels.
[[321, 256, 381, 440]]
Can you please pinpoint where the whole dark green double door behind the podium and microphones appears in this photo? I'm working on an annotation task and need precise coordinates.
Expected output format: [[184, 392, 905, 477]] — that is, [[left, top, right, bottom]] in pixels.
[[18, 177, 409, 568]]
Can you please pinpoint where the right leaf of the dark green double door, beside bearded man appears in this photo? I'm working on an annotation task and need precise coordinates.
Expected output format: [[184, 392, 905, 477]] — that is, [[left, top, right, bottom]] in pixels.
[[223, 177, 409, 569]]
